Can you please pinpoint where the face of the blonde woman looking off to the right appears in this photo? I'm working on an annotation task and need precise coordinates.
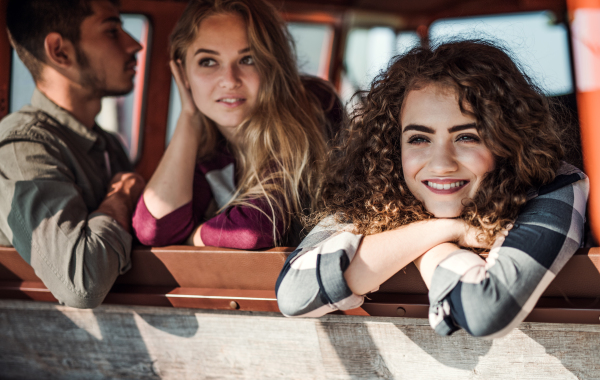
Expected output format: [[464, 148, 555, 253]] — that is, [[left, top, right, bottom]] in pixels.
[[185, 14, 260, 141]]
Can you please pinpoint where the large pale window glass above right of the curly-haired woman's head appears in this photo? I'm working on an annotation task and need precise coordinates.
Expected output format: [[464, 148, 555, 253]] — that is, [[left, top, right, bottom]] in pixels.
[[429, 12, 573, 95]]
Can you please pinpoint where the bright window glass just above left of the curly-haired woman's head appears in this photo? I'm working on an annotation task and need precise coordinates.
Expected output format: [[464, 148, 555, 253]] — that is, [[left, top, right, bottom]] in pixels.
[[341, 27, 420, 102]]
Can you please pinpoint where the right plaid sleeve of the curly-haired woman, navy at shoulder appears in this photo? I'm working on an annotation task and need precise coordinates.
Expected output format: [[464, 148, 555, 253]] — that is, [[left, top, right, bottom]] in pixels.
[[429, 173, 589, 338]]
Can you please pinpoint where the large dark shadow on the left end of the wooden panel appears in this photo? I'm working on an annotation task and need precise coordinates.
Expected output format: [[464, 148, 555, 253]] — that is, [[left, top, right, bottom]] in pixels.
[[0, 304, 160, 380]]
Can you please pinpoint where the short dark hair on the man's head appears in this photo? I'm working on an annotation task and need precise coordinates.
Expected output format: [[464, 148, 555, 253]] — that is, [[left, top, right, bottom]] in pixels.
[[6, 0, 119, 81]]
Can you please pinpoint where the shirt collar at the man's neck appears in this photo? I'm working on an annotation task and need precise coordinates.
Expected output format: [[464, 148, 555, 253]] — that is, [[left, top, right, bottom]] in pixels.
[[31, 88, 105, 151]]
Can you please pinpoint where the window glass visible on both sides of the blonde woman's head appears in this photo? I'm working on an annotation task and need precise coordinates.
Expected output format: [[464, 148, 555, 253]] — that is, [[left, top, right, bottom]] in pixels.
[[166, 22, 333, 145]]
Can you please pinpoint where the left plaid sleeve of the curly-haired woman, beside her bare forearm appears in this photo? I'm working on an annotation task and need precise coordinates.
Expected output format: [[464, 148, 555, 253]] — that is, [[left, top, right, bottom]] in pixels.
[[275, 217, 364, 317]]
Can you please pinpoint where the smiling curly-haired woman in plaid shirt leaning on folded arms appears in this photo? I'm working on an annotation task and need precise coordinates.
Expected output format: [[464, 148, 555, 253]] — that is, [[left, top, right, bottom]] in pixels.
[[277, 41, 588, 337]]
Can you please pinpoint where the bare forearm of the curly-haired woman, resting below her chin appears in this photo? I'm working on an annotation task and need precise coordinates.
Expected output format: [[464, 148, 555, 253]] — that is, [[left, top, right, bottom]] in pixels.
[[344, 219, 463, 294]]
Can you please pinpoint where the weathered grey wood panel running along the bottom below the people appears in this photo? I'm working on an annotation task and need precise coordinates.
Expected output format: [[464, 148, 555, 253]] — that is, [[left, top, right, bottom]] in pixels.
[[0, 300, 600, 379]]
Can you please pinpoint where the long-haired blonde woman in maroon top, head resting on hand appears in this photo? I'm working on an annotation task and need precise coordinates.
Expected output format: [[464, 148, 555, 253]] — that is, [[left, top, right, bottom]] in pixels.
[[133, 0, 326, 249]]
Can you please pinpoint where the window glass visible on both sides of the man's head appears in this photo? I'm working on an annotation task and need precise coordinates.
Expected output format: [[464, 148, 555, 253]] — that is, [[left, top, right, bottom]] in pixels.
[[10, 14, 150, 161]]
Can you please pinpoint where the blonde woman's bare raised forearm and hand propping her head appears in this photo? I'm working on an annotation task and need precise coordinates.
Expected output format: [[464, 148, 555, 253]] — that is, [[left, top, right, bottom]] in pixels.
[[143, 61, 201, 219]]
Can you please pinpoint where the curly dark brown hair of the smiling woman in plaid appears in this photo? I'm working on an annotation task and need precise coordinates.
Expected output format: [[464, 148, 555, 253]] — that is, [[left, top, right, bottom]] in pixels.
[[322, 40, 564, 241]]
